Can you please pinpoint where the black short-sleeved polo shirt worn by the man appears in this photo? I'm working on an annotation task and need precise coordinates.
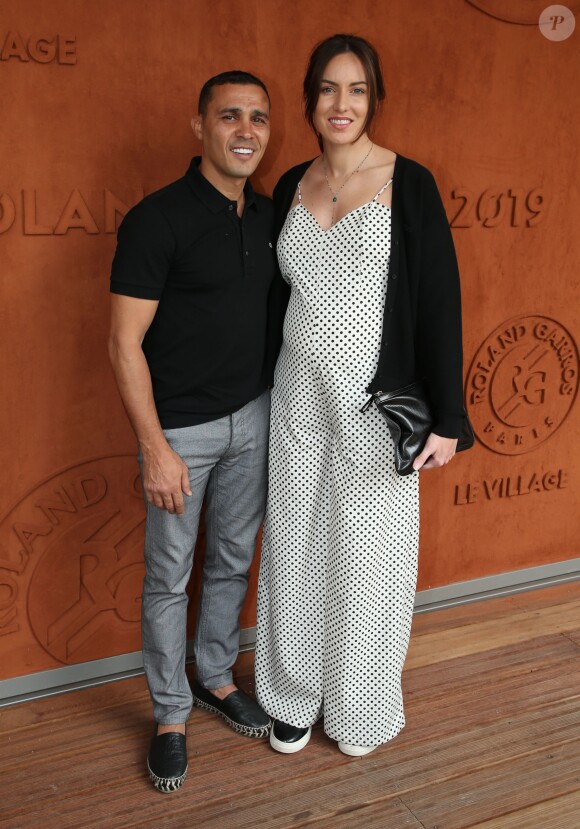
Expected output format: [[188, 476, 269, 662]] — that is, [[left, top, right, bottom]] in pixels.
[[111, 158, 276, 429]]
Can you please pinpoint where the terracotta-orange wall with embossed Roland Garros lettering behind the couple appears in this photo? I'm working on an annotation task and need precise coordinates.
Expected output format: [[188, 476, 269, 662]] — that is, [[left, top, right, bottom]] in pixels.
[[0, 0, 580, 678]]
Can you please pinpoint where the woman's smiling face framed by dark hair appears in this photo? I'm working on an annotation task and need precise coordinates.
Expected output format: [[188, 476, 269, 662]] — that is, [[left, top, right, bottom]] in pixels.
[[314, 52, 369, 144]]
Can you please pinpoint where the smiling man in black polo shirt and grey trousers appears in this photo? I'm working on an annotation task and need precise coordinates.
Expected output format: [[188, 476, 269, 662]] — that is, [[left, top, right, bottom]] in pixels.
[[109, 71, 276, 792]]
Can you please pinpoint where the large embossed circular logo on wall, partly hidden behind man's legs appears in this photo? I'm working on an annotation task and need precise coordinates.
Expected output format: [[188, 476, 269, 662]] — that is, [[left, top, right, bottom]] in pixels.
[[0, 456, 145, 671]]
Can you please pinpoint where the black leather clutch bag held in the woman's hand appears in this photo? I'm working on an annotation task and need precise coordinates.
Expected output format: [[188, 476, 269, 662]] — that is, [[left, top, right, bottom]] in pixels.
[[361, 381, 474, 475]]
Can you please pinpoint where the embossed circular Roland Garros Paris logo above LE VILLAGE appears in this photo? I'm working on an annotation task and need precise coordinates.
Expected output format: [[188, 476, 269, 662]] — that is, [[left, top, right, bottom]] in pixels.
[[466, 316, 579, 455]]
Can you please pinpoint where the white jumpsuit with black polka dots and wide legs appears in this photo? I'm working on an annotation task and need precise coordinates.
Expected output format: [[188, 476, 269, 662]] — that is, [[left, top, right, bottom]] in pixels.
[[256, 182, 419, 746]]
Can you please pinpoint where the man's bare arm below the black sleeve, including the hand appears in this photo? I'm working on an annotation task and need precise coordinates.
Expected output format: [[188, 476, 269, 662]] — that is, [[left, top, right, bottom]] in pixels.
[[109, 294, 191, 515]]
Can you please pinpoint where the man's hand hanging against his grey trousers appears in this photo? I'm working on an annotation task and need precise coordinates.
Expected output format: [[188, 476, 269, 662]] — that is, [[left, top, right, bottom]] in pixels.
[[143, 446, 191, 515]]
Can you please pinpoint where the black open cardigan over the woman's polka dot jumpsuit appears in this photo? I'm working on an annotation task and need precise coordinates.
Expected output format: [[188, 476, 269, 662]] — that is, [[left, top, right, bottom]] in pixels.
[[270, 155, 464, 437]]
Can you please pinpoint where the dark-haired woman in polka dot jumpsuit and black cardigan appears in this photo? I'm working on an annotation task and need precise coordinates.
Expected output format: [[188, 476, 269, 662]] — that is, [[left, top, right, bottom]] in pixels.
[[256, 35, 463, 756]]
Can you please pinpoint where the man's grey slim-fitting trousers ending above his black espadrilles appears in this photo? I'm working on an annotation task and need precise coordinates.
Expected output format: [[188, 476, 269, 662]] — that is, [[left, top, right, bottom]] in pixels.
[[140, 392, 270, 725]]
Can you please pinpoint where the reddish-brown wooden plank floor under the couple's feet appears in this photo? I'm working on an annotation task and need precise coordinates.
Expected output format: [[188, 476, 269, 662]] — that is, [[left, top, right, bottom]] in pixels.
[[0, 583, 580, 829]]
